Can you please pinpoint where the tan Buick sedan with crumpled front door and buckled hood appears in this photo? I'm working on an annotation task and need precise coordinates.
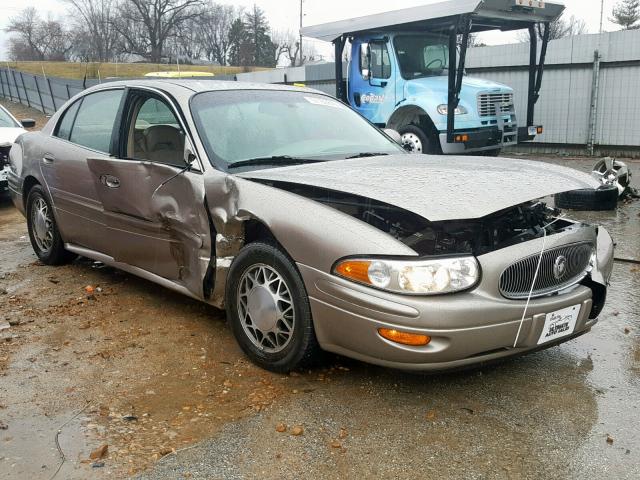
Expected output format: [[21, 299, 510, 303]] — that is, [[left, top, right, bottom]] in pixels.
[[9, 79, 613, 372]]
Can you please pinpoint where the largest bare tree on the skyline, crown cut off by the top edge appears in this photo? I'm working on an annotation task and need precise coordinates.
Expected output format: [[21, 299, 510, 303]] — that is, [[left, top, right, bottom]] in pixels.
[[115, 0, 202, 62]]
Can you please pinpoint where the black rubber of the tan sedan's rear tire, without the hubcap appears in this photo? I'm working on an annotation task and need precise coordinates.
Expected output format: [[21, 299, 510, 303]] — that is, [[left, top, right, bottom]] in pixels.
[[26, 185, 77, 265]]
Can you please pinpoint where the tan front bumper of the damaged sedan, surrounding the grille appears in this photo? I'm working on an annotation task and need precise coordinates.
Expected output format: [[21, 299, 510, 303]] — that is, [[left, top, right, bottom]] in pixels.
[[298, 226, 613, 370]]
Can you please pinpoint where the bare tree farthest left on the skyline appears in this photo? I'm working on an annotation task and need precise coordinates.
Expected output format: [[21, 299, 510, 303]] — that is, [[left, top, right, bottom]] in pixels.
[[5, 7, 71, 60]]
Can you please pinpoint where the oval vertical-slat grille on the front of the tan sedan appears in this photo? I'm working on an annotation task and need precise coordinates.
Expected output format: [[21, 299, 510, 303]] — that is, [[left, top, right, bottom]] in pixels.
[[500, 242, 593, 299]]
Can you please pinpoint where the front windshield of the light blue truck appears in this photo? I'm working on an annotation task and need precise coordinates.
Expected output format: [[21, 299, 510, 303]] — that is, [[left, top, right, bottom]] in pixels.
[[394, 35, 449, 80]]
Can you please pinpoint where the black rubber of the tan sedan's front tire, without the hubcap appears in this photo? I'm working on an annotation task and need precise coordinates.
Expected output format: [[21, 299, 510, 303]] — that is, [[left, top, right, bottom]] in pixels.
[[225, 243, 321, 373]]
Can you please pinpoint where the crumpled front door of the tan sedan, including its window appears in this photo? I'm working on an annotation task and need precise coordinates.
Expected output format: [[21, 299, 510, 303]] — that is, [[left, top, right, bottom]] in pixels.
[[89, 89, 211, 298]]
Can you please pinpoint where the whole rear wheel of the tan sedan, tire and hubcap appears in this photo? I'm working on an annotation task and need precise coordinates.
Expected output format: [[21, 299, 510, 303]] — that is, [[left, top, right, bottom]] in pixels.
[[27, 185, 76, 265]]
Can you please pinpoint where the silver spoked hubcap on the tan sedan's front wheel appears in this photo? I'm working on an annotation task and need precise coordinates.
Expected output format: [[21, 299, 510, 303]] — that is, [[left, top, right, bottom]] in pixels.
[[238, 264, 295, 353]]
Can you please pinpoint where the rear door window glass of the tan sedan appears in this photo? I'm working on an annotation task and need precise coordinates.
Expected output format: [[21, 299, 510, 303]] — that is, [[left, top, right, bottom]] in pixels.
[[69, 90, 123, 153]]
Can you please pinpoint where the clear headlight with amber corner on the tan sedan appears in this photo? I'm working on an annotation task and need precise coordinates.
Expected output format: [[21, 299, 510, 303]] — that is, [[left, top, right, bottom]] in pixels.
[[333, 256, 480, 295]]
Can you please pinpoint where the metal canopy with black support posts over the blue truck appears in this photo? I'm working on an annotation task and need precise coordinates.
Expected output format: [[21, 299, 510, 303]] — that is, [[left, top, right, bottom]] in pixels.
[[301, 0, 565, 143]]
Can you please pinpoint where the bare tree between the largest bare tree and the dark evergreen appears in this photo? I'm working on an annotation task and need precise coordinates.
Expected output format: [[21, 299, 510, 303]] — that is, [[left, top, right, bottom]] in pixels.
[[198, 0, 243, 65]]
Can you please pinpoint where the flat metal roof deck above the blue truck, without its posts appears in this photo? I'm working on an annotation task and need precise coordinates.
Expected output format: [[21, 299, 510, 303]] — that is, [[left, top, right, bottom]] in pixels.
[[301, 0, 564, 42]]
